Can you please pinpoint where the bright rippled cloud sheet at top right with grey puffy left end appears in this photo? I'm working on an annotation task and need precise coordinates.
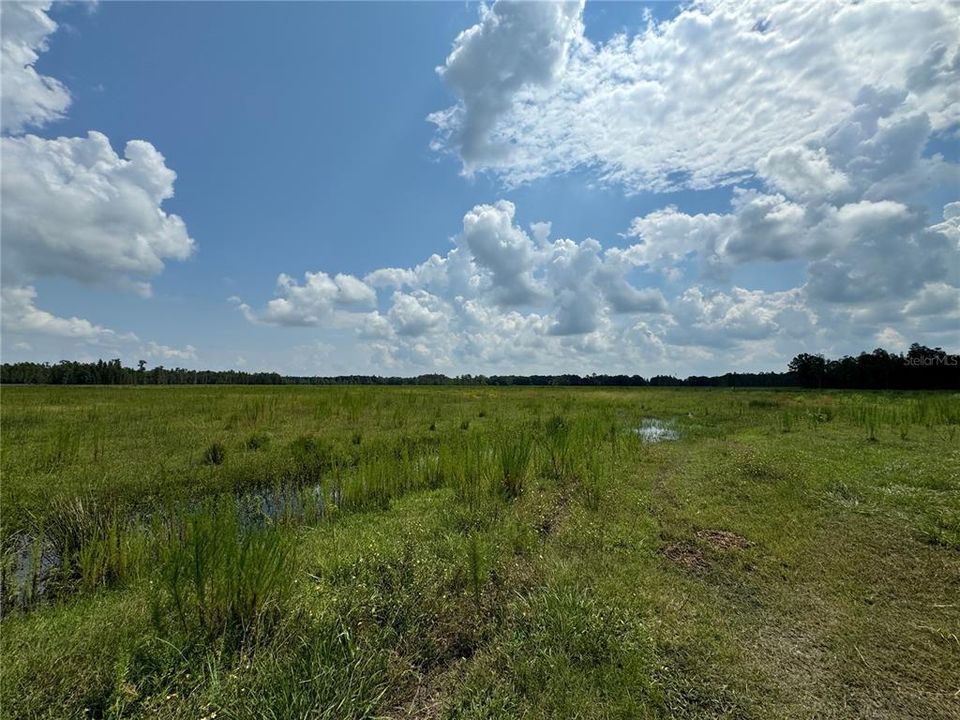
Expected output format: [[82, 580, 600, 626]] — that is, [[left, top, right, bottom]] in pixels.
[[430, 0, 960, 192]]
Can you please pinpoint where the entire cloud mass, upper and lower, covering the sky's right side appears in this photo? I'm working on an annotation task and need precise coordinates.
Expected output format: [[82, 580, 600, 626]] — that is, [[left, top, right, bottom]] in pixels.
[[243, 0, 960, 372]]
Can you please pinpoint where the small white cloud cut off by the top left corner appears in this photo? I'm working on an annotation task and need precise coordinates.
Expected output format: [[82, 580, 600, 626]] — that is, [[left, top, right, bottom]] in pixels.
[[0, 2, 70, 133]]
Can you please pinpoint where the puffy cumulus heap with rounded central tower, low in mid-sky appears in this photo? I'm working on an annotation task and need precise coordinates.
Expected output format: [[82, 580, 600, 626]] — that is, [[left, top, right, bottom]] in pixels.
[[238, 200, 666, 338]]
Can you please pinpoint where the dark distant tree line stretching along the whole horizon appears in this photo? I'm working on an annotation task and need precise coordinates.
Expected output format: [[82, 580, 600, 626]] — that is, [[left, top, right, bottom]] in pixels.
[[0, 343, 960, 390]]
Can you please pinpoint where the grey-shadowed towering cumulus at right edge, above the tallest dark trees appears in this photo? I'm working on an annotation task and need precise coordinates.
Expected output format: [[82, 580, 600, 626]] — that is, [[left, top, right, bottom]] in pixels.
[[616, 60, 960, 341]]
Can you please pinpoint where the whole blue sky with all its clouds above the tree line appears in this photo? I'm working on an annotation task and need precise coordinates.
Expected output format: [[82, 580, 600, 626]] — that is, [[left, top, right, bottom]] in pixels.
[[0, 0, 960, 376]]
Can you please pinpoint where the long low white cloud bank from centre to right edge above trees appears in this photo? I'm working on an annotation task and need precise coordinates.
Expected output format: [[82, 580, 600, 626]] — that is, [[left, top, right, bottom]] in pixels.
[[238, 179, 960, 374]]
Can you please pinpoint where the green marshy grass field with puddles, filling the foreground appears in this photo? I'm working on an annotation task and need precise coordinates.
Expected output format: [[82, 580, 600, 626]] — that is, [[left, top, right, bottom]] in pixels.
[[0, 387, 960, 719]]
